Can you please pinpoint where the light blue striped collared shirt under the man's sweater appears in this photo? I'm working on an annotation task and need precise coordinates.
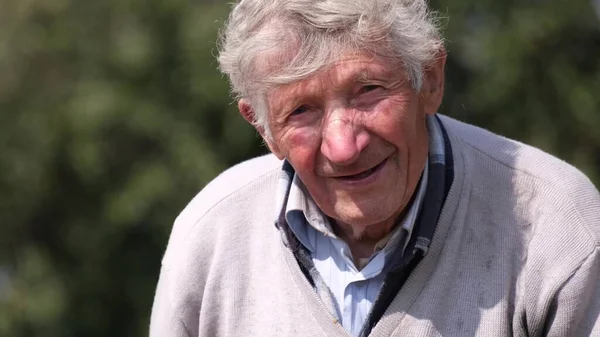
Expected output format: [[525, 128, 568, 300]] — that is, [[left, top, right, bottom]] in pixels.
[[285, 163, 428, 337]]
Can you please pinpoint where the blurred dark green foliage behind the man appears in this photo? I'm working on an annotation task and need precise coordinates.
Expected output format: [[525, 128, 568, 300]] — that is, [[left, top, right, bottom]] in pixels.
[[0, 0, 600, 337]]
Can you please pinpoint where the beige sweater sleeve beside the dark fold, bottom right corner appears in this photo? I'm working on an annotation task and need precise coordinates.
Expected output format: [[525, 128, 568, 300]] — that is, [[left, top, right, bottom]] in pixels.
[[544, 247, 600, 337]]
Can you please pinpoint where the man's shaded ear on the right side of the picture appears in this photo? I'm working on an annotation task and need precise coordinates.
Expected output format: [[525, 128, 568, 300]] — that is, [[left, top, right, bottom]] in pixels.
[[421, 49, 446, 115]]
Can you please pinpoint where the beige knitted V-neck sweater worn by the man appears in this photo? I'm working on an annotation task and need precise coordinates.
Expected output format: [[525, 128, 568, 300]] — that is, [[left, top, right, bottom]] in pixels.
[[150, 117, 600, 337]]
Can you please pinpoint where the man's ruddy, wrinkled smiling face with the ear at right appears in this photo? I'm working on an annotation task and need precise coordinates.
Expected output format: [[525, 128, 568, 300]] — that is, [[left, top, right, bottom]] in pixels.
[[241, 54, 443, 227]]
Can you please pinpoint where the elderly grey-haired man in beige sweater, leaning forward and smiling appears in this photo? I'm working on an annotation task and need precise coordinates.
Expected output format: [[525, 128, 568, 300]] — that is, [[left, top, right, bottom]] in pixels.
[[150, 0, 600, 337]]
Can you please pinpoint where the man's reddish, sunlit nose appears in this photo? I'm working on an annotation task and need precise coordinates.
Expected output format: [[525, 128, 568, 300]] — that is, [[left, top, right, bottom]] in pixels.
[[321, 112, 370, 165]]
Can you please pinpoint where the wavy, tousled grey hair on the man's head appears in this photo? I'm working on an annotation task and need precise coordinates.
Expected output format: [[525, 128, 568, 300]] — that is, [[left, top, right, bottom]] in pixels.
[[218, 0, 443, 135]]
